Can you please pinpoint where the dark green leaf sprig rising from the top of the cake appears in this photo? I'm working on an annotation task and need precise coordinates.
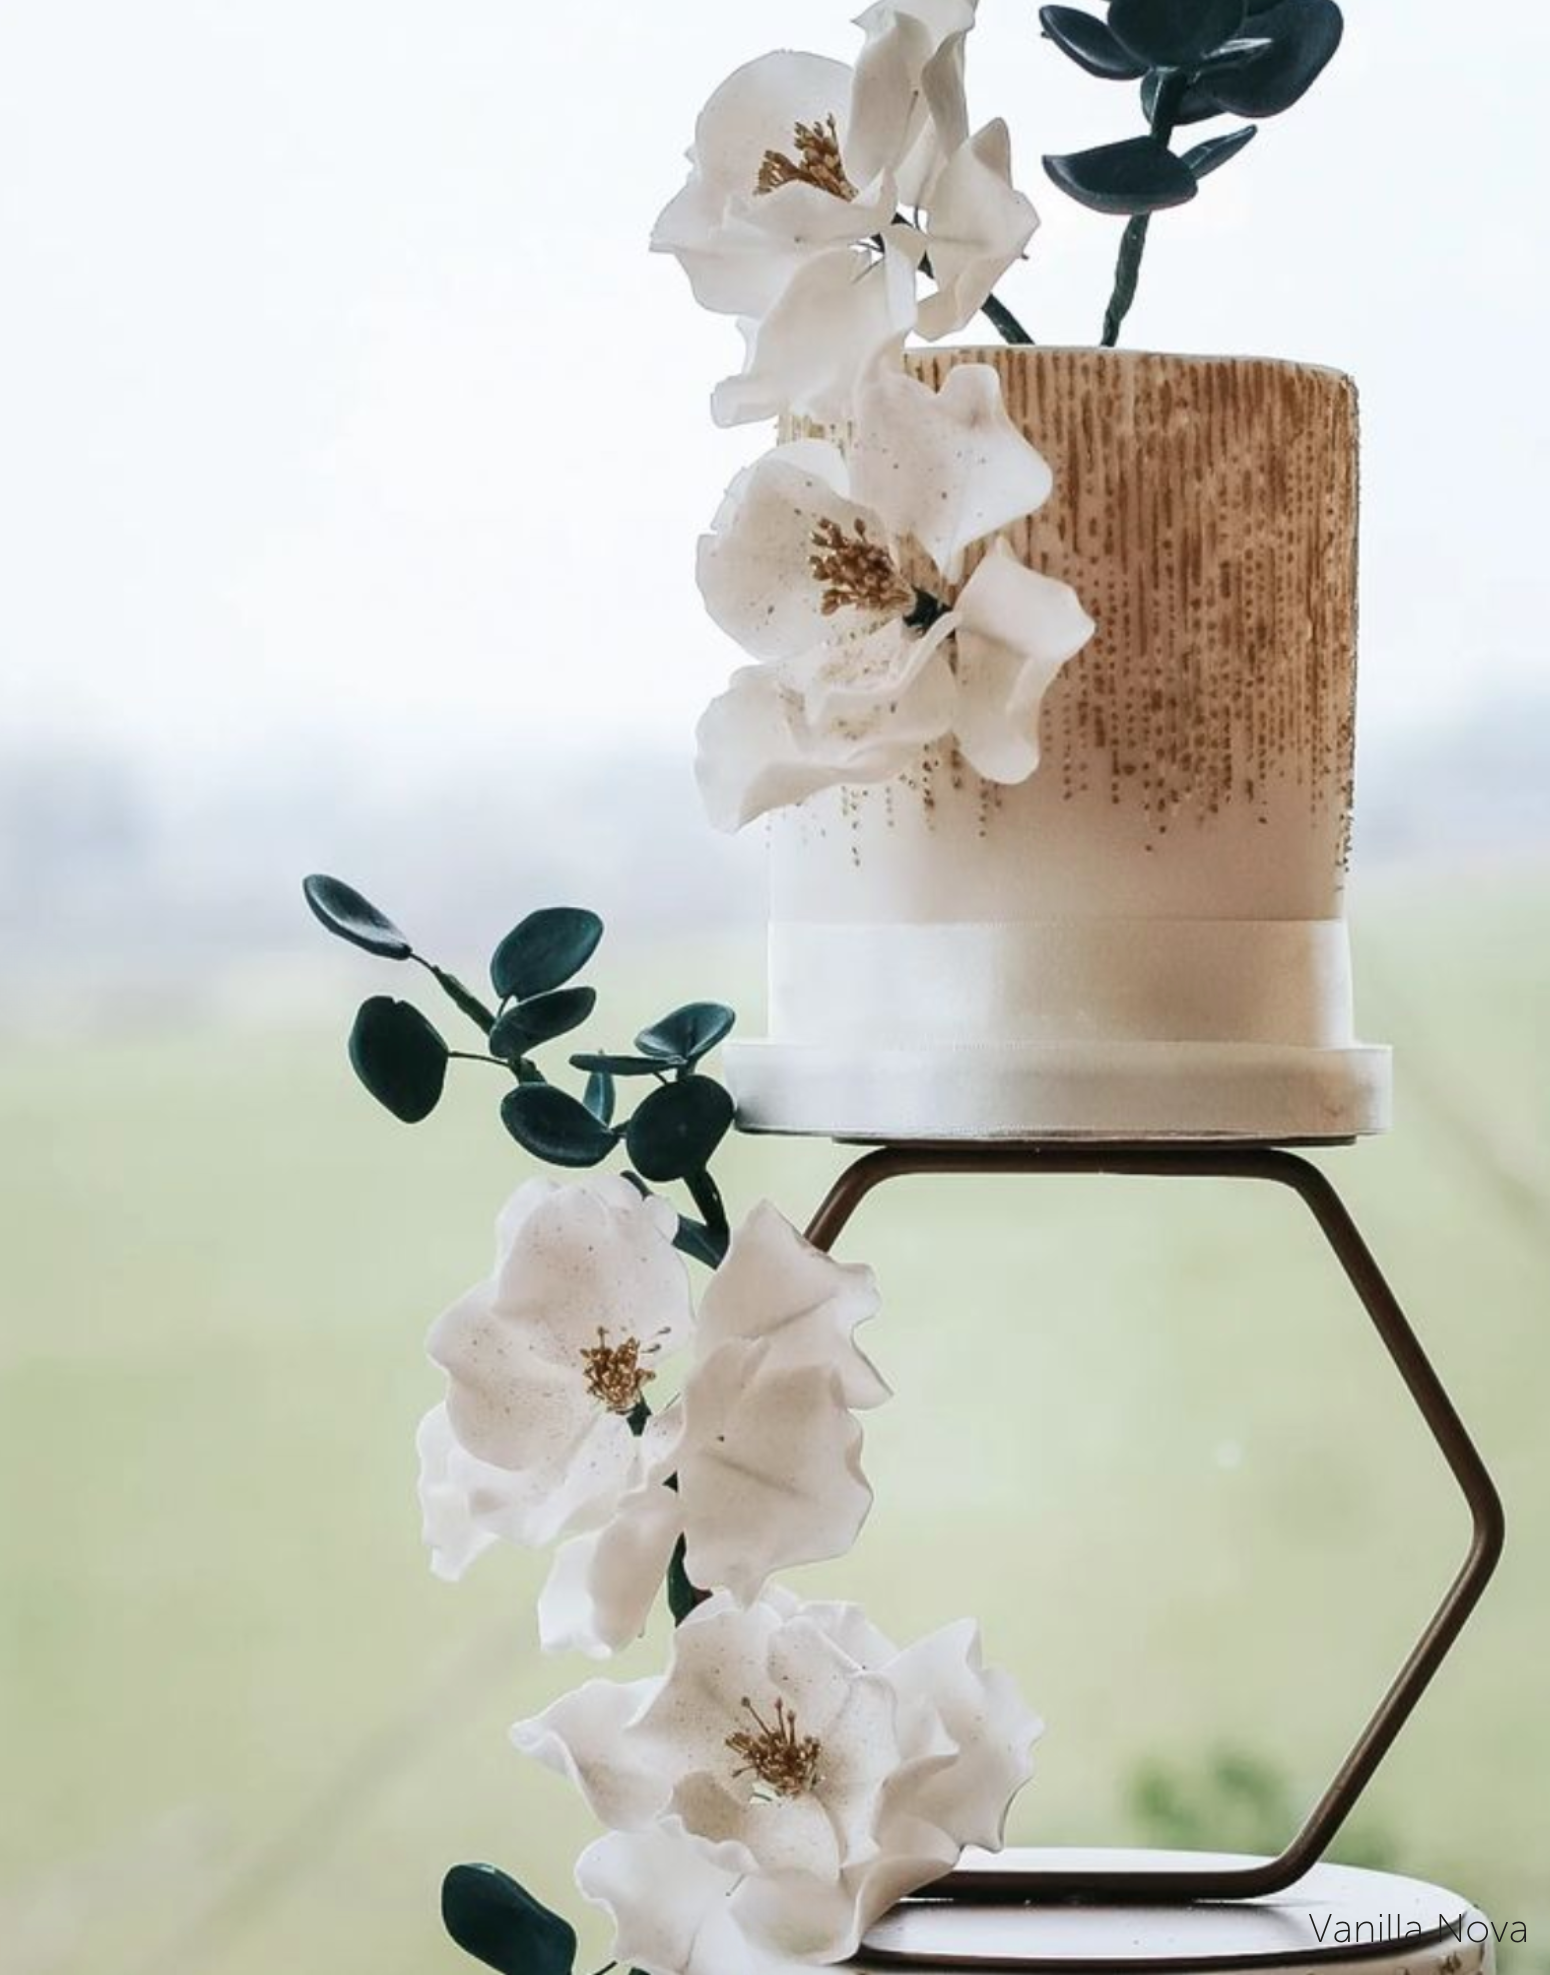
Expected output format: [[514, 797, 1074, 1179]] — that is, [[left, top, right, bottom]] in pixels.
[[1039, 0, 1345, 348]]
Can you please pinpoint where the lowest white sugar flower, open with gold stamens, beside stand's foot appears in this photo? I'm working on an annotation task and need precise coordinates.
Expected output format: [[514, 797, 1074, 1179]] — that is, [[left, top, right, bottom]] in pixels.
[[513, 1592, 1041, 1975]]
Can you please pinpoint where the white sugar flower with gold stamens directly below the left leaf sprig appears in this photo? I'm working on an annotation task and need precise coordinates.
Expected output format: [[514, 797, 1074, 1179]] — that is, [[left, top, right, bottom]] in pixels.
[[421, 1177, 691, 1574]]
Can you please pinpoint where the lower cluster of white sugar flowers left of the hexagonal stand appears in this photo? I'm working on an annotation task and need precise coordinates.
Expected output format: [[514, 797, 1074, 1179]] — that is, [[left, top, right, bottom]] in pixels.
[[421, 1177, 1039, 1975]]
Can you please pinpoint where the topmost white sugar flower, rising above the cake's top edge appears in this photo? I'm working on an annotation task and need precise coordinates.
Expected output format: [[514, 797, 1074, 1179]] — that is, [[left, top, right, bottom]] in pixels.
[[652, 0, 1037, 425]]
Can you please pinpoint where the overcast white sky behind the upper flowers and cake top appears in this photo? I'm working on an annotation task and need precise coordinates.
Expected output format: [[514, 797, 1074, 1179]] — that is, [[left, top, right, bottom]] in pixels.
[[0, 0, 1550, 797]]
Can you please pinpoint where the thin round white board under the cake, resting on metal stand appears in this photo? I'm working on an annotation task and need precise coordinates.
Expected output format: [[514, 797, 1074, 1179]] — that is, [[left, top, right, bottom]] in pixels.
[[727, 1043, 1392, 1146]]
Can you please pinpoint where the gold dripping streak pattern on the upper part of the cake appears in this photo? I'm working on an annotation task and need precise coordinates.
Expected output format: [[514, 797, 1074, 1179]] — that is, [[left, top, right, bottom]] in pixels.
[[797, 348, 1356, 855]]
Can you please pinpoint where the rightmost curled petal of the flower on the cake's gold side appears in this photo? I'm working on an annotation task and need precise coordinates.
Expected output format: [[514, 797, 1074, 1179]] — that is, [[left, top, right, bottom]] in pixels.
[[954, 543, 1096, 782]]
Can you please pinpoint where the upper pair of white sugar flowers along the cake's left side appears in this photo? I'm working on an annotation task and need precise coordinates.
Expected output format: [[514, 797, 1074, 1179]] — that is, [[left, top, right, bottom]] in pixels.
[[652, 0, 1094, 830]]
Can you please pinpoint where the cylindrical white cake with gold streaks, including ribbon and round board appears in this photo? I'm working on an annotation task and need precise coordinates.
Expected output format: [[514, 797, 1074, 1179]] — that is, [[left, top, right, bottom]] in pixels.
[[729, 350, 1388, 1140]]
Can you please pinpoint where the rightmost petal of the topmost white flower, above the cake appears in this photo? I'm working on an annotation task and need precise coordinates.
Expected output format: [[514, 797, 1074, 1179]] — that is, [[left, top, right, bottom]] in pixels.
[[920, 120, 1039, 342]]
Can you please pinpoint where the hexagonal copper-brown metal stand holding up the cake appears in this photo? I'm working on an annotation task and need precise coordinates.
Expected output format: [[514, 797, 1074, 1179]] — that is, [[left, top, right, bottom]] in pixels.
[[808, 1144, 1505, 1904]]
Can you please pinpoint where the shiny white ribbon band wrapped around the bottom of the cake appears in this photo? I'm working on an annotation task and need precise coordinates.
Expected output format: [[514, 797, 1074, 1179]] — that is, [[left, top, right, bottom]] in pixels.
[[770, 918, 1353, 1049]]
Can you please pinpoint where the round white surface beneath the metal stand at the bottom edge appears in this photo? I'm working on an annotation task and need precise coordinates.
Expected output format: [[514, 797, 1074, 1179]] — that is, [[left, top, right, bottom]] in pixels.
[[851, 1851, 1495, 1975]]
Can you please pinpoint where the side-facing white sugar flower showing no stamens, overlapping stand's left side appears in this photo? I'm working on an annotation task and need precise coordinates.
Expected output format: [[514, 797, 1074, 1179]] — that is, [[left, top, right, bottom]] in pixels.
[[539, 1205, 889, 1657]]
